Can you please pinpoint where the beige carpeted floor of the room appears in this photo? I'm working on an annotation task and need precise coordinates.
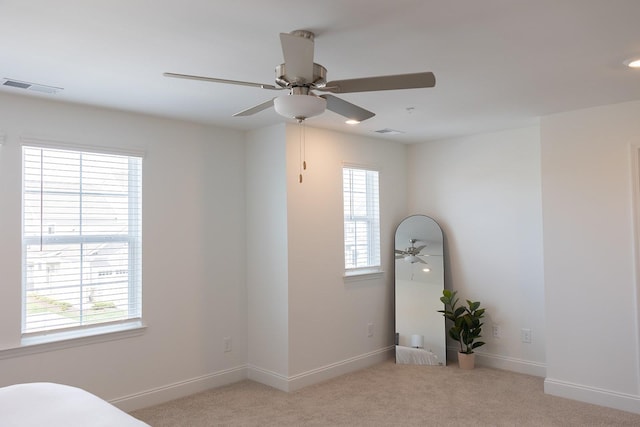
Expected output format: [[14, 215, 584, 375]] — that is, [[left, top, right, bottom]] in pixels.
[[132, 361, 640, 427]]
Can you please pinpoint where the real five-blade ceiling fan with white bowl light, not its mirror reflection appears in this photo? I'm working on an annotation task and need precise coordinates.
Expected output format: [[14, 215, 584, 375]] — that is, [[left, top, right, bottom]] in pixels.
[[164, 30, 436, 122]]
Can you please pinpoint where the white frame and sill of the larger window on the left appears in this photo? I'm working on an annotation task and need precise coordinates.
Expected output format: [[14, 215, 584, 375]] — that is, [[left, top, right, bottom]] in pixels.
[[18, 138, 145, 348]]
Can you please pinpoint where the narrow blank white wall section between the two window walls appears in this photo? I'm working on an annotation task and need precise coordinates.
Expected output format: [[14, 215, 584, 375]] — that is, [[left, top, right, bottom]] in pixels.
[[245, 124, 289, 387]]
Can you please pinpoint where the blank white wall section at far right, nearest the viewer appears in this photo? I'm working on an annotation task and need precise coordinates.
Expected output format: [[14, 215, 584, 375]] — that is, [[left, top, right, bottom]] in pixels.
[[541, 102, 640, 413]]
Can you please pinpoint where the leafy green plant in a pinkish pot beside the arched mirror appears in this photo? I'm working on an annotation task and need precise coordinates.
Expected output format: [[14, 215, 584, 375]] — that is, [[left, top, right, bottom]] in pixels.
[[438, 289, 485, 369]]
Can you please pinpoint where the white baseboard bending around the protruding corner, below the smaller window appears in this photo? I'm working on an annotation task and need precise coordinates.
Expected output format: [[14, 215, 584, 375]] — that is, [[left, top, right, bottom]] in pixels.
[[248, 346, 395, 392]]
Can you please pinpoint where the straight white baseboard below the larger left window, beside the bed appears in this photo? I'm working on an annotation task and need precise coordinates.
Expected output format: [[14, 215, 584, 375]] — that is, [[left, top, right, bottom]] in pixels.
[[109, 365, 247, 412]]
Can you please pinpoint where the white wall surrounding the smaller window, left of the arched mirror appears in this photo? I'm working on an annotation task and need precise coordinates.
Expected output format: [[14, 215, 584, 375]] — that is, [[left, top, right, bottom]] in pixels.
[[287, 125, 407, 384]]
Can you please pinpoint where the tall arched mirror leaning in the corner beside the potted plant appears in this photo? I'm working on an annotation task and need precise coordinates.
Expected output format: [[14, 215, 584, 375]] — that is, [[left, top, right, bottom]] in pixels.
[[395, 215, 447, 365]]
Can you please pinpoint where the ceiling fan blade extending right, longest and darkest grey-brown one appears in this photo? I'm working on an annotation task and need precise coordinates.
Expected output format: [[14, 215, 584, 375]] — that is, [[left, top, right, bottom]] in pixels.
[[318, 72, 436, 93]]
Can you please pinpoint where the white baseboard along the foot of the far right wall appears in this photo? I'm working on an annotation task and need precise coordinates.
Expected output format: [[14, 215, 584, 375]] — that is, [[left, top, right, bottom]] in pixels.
[[544, 378, 640, 414]]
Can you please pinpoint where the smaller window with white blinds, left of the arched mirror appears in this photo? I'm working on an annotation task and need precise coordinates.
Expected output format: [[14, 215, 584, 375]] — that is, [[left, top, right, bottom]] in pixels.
[[342, 167, 380, 274]]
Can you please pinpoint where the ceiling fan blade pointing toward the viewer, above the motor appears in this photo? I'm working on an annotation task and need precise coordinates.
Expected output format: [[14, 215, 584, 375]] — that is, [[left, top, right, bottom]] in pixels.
[[280, 31, 314, 83]]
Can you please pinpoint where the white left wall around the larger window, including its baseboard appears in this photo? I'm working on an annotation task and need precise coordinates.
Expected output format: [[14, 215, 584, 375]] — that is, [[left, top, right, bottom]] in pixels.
[[0, 94, 247, 409]]
